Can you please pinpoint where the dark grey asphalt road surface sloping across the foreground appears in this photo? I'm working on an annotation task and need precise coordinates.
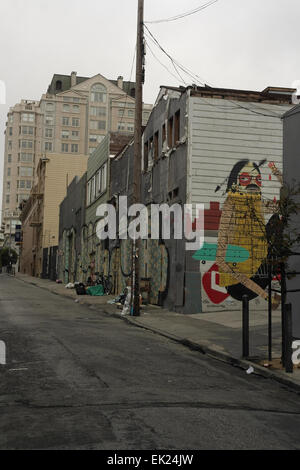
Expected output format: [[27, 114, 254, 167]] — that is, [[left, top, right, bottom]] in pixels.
[[0, 275, 300, 450]]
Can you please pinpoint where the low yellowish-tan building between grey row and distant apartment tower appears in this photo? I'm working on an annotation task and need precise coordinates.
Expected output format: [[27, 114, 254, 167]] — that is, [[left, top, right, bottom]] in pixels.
[[20, 153, 88, 276]]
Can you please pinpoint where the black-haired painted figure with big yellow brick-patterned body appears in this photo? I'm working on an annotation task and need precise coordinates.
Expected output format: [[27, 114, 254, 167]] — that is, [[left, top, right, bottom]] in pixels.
[[216, 160, 282, 300]]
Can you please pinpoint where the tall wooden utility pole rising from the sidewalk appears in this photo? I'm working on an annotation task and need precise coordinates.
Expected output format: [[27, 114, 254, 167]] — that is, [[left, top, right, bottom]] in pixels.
[[133, 0, 145, 316]]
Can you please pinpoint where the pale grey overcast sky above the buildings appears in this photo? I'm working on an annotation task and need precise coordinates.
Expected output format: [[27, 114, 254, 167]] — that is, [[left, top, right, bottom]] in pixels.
[[0, 0, 300, 209]]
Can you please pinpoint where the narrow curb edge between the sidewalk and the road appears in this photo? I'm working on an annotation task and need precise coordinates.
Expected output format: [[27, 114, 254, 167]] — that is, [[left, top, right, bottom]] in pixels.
[[15, 276, 300, 393]]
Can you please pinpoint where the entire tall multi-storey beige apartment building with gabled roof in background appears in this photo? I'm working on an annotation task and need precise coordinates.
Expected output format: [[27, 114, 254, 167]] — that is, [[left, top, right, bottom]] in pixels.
[[2, 72, 152, 233]]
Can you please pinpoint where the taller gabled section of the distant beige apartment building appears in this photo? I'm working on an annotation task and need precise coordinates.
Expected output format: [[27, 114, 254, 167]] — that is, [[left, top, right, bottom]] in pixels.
[[41, 72, 152, 155]]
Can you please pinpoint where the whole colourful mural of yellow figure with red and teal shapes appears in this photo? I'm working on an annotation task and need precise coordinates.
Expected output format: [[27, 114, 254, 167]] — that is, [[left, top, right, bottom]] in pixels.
[[193, 160, 282, 308]]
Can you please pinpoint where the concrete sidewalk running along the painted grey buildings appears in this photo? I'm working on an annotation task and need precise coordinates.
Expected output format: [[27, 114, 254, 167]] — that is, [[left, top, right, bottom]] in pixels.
[[16, 273, 300, 391]]
